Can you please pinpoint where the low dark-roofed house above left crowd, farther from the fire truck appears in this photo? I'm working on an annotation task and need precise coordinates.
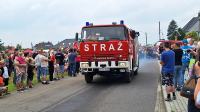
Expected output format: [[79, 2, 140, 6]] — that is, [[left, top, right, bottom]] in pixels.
[[34, 42, 54, 50]]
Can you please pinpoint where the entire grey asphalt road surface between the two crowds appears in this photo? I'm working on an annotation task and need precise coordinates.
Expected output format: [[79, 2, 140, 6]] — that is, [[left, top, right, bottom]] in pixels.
[[0, 60, 159, 112]]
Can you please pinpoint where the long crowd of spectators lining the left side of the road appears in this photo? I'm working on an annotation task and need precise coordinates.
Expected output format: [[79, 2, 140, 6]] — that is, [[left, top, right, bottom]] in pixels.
[[0, 48, 80, 96]]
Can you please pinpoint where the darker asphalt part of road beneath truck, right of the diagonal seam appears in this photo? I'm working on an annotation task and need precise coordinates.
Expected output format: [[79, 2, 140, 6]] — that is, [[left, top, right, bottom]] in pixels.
[[47, 60, 159, 112]]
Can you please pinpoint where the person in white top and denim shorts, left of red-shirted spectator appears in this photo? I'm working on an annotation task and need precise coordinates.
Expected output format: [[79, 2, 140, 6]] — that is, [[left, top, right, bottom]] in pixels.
[[41, 52, 49, 84]]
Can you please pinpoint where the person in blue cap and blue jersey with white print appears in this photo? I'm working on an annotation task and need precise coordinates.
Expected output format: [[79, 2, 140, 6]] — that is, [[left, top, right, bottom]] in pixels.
[[180, 39, 192, 87]]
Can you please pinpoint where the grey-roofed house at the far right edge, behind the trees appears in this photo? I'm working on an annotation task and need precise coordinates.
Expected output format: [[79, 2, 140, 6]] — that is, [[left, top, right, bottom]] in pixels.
[[183, 12, 200, 32]]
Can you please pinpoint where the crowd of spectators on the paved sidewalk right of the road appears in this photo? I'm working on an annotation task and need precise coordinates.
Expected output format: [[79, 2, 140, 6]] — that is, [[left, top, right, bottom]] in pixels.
[[159, 39, 200, 112]]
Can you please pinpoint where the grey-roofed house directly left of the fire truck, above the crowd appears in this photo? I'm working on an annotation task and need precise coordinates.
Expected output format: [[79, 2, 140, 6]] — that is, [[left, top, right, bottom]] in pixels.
[[54, 39, 75, 49]]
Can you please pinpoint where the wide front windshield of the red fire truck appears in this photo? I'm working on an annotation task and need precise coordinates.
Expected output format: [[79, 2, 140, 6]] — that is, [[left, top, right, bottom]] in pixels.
[[82, 26, 126, 41]]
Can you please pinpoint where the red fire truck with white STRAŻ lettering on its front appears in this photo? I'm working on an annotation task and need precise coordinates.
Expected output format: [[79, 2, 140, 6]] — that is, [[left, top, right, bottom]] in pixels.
[[76, 21, 139, 83]]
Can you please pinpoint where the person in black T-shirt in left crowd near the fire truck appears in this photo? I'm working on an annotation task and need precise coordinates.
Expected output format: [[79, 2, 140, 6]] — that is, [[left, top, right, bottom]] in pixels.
[[55, 49, 65, 78]]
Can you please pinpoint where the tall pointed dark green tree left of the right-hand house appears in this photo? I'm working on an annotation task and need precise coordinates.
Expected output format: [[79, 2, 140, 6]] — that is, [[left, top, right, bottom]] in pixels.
[[167, 20, 178, 40]]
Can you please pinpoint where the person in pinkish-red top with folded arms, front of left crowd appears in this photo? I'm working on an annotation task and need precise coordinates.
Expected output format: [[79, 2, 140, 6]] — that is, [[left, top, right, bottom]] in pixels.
[[14, 52, 26, 92]]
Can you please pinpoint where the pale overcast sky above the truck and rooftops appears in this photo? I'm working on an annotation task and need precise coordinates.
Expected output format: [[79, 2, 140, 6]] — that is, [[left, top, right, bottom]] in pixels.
[[0, 0, 200, 47]]
